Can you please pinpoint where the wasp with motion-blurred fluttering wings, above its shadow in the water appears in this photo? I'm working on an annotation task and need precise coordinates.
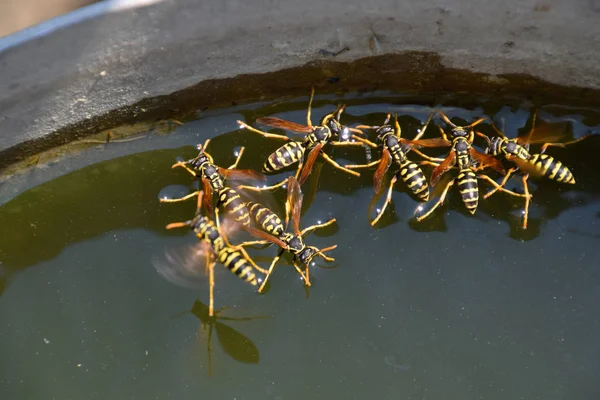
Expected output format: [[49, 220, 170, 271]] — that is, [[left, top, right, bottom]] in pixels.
[[154, 192, 267, 316]]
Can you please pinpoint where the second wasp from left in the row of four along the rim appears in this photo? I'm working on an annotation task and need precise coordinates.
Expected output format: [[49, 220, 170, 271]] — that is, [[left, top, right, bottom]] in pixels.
[[346, 114, 433, 226]]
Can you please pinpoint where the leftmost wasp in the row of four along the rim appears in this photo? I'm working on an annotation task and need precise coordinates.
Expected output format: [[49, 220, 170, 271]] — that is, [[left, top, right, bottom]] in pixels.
[[237, 88, 364, 191]]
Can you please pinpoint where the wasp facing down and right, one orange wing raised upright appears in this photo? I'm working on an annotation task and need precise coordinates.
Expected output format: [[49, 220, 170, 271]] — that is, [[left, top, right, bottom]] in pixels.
[[240, 176, 337, 292]]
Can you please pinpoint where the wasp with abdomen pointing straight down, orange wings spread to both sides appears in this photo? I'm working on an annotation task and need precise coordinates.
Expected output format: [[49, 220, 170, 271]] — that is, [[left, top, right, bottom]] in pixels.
[[409, 112, 506, 221]]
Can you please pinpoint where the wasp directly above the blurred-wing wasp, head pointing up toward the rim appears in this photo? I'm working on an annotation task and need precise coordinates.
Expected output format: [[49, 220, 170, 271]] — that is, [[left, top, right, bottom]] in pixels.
[[160, 139, 266, 225]]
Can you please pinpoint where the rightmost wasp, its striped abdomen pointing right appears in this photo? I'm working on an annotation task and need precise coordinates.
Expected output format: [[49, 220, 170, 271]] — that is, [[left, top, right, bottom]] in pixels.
[[477, 111, 589, 229]]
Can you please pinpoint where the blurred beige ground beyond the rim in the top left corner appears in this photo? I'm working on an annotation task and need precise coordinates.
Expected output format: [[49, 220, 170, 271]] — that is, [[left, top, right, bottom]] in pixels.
[[0, 0, 98, 37]]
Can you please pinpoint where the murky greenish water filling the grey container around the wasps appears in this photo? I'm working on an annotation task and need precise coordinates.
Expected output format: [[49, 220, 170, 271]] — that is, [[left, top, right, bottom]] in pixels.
[[0, 93, 600, 400]]
